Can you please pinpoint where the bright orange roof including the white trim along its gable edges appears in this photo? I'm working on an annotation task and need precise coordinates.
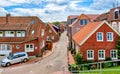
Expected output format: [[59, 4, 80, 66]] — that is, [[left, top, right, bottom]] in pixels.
[[72, 21, 119, 45]]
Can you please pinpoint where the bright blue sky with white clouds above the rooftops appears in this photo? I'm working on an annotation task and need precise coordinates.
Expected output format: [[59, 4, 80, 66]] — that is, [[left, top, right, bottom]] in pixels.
[[0, 0, 120, 22]]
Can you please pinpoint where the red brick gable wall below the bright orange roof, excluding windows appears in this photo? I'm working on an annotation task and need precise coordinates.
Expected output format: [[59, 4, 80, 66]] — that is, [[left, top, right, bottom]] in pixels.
[[79, 25, 118, 60]]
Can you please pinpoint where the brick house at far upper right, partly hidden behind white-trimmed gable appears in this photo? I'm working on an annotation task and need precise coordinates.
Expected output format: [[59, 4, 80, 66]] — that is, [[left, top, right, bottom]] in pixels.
[[96, 7, 120, 33]]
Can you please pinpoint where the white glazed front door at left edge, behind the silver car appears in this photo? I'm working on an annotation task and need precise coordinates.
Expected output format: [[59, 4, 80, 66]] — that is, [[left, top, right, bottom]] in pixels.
[[0, 44, 12, 55]]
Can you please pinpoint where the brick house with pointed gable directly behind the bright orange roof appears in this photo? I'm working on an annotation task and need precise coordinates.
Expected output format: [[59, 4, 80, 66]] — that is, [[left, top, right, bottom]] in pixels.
[[67, 14, 98, 48]]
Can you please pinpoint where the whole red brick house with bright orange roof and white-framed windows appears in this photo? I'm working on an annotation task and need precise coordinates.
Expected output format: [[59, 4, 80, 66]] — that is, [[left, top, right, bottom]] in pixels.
[[72, 21, 119, 61]]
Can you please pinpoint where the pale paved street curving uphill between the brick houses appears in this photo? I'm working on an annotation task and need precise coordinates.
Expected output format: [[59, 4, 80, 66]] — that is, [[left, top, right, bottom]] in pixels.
[[2, 32, 68, 74]]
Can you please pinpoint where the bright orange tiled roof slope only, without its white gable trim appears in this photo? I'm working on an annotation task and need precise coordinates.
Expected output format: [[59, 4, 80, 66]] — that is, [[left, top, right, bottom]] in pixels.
[[72, 22, 101, 44]]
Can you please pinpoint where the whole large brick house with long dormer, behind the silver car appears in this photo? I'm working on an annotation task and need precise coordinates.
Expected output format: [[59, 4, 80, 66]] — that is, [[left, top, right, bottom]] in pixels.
[[0, 14, 46, 55]]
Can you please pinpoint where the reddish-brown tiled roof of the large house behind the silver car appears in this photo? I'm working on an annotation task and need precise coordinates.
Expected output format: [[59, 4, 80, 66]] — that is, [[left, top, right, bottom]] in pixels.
[[0, 16, 44, 43]]
